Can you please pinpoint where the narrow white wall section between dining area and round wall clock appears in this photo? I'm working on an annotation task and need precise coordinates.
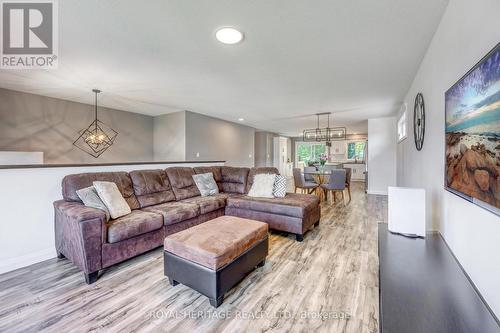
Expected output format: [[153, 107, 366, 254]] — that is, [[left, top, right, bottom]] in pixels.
[[368, 117, 396, 195]]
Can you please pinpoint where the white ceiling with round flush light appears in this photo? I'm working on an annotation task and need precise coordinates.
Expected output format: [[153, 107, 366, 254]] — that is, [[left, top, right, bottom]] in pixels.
[[0, 0, 448, 135]]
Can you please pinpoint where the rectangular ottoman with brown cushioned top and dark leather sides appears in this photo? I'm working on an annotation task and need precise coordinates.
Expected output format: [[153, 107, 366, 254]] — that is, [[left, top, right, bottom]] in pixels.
[[164, 216, 268, 307]]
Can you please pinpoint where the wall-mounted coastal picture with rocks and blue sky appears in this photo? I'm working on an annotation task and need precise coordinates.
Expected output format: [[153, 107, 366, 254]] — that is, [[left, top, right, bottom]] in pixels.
[[445, 43, 500, 215]]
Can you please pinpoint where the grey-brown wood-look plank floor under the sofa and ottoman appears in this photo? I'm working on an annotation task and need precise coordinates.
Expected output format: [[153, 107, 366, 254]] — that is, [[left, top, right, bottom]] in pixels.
[[0, 183, 387, 333]]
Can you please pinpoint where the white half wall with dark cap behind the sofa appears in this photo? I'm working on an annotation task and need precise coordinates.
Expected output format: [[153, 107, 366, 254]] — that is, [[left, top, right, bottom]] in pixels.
[[0, 163, 222, 274]]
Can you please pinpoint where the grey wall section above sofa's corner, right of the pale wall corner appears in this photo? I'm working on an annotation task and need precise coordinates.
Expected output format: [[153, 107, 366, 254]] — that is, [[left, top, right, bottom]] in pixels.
[[186, 111, 255, 167]]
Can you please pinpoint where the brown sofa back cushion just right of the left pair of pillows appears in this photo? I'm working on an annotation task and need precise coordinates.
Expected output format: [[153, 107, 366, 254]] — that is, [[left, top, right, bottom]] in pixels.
[[130, 169, 175, 208]]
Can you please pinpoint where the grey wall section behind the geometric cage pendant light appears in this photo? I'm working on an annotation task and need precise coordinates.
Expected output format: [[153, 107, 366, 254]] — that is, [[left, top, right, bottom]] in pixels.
[[0, 89, 153, 164]]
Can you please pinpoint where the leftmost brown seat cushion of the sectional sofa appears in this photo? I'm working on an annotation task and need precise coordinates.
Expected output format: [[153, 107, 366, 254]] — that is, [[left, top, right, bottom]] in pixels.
[[107, 210, 163, 243]]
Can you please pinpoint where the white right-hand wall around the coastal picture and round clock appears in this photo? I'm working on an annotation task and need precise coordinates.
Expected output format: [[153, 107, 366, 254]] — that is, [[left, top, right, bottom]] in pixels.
[[398, 0, 500, 317]]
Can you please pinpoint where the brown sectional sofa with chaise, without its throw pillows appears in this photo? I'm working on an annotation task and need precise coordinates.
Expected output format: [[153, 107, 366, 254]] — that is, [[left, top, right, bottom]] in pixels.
[[54, 166, 320, 283]]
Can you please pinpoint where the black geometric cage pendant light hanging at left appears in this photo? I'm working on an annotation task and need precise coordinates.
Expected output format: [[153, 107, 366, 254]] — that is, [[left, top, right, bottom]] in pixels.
[[73, 89, 118, 158]]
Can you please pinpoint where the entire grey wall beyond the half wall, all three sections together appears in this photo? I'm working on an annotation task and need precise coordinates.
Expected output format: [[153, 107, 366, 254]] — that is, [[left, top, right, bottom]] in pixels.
[[0, 89, 258, 167]]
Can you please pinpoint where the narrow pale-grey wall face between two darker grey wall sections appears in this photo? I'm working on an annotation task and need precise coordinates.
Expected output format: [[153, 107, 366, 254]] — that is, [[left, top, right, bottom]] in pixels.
[[153, 111, 186, 161]]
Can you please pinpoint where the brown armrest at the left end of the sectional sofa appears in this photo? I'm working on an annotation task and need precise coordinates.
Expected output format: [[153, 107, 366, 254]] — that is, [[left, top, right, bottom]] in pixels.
[[54, 200, 106, 274]]
